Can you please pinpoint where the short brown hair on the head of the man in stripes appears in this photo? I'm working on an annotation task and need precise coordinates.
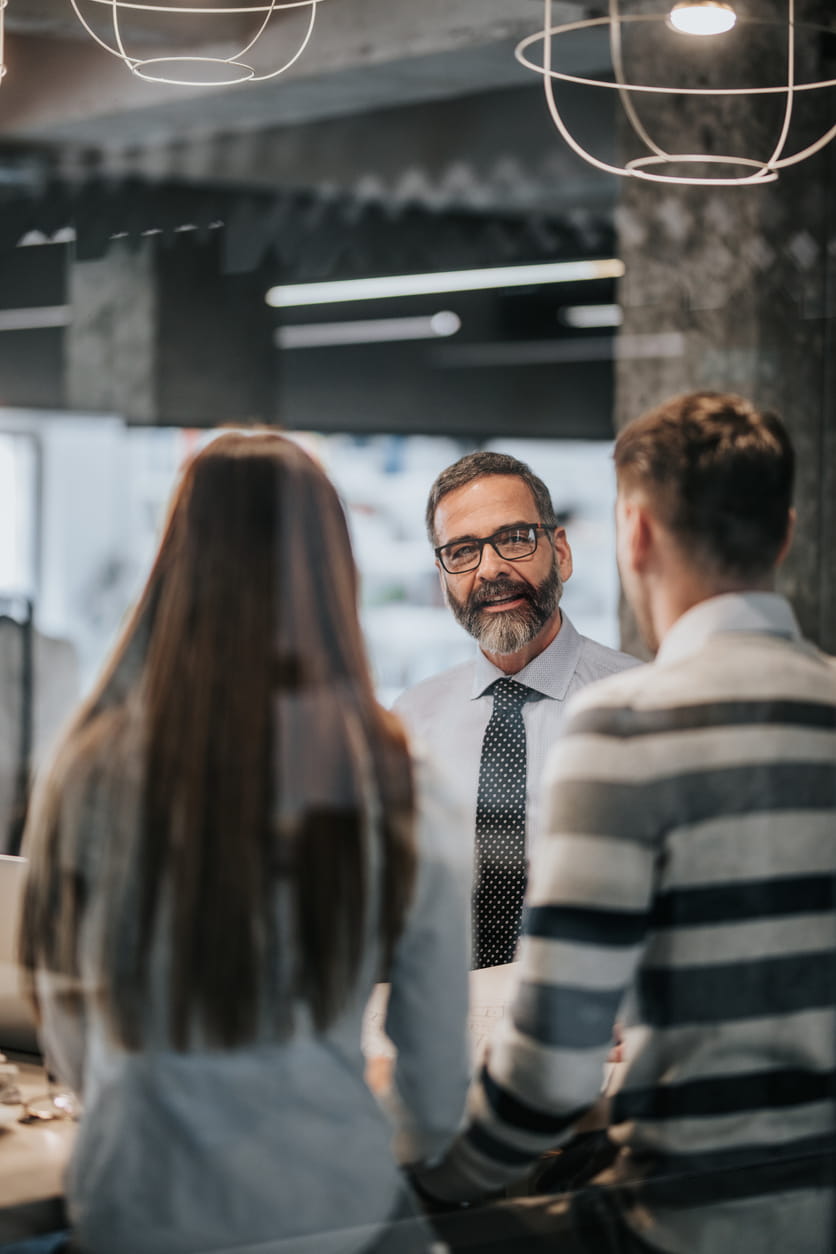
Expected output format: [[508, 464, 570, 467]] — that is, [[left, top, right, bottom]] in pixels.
[[614, 391, 795, 579]]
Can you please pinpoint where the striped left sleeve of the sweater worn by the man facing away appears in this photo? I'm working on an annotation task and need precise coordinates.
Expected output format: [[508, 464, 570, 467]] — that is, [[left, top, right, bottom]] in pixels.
[[417, 706, 656, 1201]]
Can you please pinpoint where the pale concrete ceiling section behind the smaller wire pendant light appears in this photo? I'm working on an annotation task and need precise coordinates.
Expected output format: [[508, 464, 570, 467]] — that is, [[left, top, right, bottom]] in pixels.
[[0, 0, 588, 145]]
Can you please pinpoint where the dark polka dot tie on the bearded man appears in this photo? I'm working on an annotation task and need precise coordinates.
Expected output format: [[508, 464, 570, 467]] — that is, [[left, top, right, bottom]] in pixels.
[[473, 678, 534, 967]]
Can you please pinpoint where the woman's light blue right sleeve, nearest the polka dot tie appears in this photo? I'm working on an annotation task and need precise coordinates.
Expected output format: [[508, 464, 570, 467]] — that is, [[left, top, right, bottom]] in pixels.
[[386, 747, 471, 1161]]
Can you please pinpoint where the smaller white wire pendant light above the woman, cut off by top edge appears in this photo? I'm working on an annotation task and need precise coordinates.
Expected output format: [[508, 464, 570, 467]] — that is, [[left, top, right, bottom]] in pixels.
[[69, 0, 323, 87]]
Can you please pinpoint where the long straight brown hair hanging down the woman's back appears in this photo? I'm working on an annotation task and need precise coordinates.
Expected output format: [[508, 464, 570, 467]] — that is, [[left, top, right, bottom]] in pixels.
[[21, 431, 415, 1048]]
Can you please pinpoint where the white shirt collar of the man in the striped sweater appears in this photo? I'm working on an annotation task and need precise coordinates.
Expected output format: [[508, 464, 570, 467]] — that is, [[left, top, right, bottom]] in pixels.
[[656, 592, 801, 662]]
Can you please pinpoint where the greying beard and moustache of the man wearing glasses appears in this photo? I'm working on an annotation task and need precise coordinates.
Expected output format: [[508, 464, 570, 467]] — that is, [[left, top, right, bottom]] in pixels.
[[446, 561, 563, 655]]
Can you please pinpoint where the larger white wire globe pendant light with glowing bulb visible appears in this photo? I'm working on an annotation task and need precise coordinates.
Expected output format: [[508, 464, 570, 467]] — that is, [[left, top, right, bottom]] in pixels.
[[516, 0, 836, 187]]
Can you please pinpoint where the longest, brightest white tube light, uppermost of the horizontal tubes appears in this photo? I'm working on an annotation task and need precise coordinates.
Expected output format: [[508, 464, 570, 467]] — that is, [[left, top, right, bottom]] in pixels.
[[264, 257, 624, 308]]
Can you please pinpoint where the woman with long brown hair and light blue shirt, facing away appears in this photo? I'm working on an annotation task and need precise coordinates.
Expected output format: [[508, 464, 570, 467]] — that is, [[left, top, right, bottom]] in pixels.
[[21, 433, 469, 1254]]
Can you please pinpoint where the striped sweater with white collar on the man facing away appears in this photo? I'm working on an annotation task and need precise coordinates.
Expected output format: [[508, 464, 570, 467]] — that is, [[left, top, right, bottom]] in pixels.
[[425, 593, 836, 1254]]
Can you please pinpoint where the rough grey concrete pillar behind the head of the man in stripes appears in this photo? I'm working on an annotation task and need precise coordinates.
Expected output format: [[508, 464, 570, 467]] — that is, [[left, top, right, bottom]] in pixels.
[[615, 0, 836, 652]]
